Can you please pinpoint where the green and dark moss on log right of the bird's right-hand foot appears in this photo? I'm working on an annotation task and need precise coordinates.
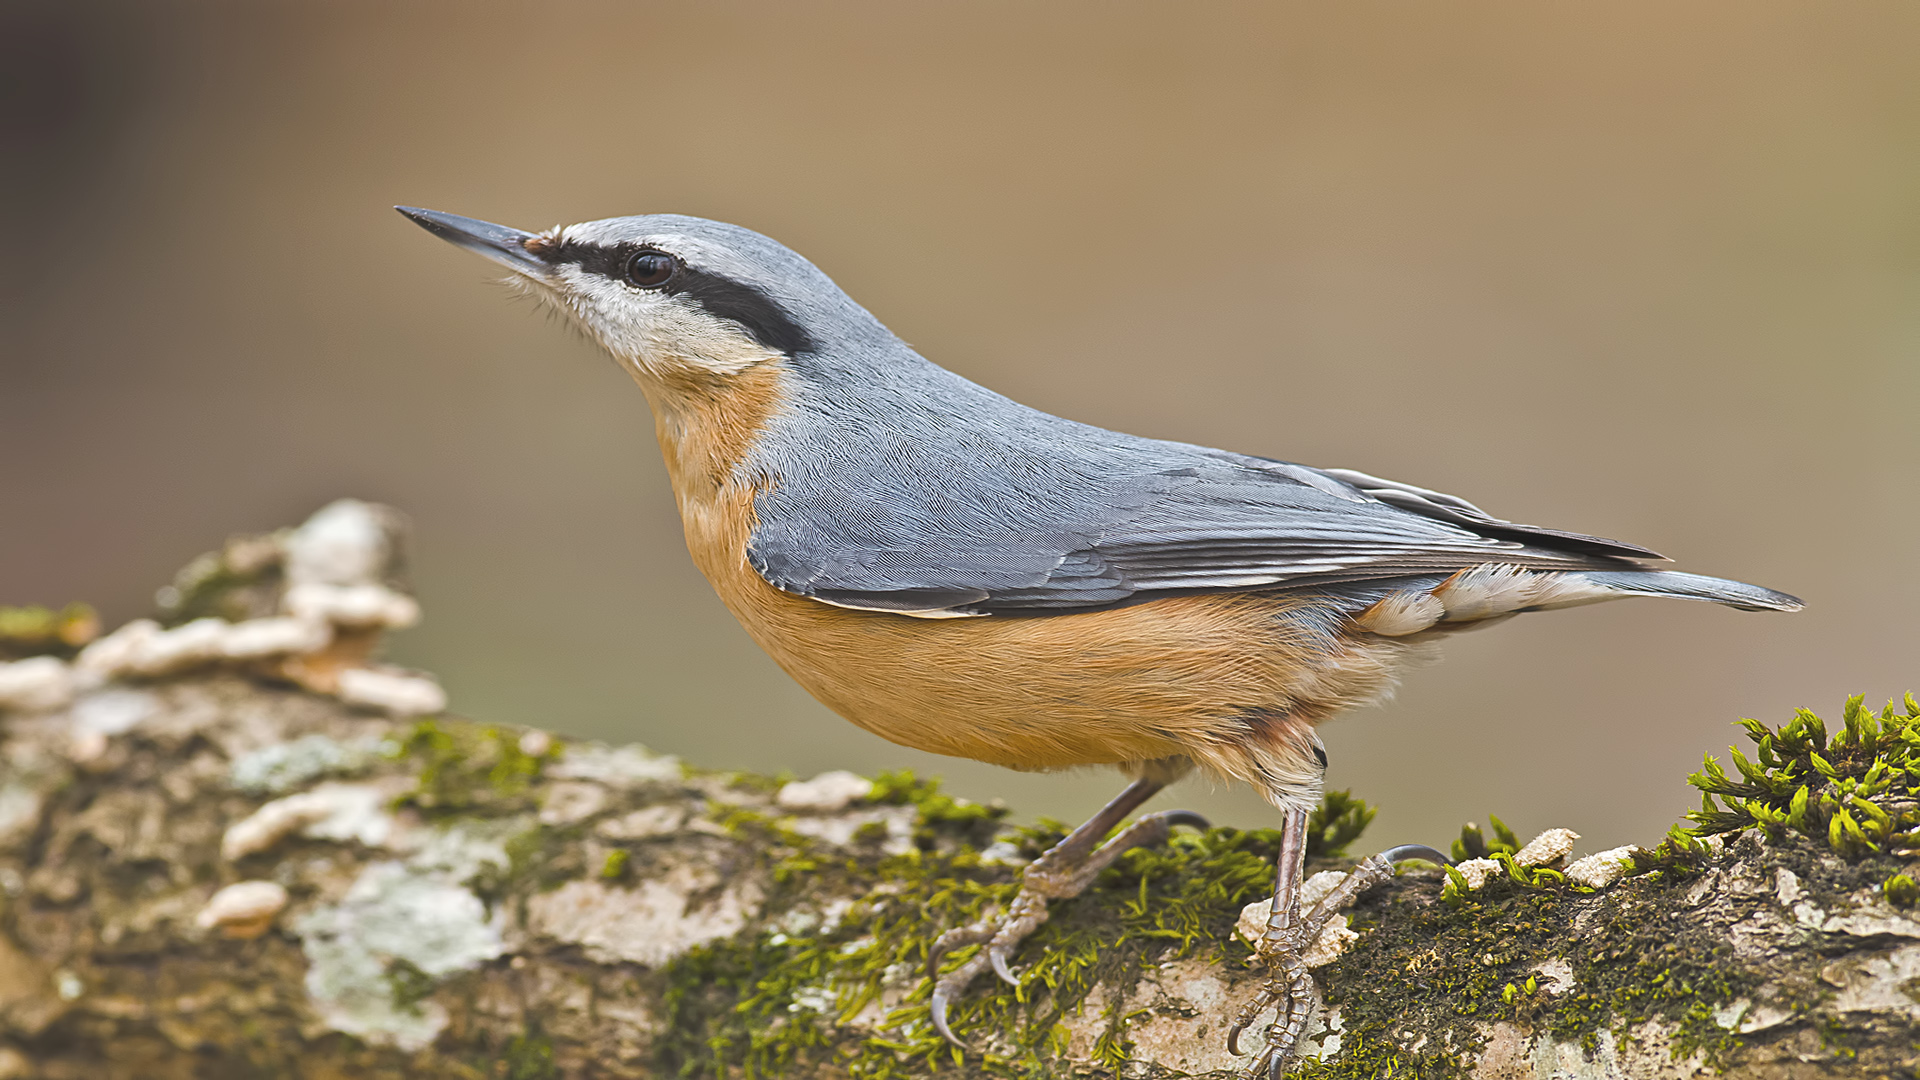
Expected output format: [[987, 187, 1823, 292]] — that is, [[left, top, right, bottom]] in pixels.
[[1304, 698, 1920, 1080]]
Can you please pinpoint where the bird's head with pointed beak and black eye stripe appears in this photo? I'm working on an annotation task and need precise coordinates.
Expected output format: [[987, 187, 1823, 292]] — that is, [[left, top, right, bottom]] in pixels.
[[396, 206, 918, 382]]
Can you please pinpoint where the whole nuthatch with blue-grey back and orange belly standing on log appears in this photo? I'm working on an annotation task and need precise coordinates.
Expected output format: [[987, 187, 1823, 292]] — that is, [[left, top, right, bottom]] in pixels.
[[396, 206, 1801, 1078]]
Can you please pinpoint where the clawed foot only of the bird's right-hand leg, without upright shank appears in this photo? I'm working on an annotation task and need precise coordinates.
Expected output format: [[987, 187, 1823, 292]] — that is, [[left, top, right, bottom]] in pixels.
[[1227, 844, 1448, 1080]]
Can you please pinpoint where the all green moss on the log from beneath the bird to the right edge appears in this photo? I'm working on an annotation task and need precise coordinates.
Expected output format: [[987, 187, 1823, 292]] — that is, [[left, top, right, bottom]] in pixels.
[[659, 701, 1920, 1080]]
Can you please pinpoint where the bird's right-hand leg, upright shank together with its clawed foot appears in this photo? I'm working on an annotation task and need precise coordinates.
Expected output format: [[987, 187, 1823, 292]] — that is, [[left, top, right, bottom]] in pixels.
[[1227, 809, 1448, 1080]]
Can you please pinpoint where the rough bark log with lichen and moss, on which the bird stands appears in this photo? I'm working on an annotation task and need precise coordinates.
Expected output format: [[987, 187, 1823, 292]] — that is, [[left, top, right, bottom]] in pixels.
[[0, 499, 1920, 1080]]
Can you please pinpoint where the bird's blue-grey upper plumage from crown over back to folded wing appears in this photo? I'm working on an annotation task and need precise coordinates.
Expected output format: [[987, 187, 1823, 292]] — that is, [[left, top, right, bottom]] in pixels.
[[555, 215, 1766, 613]]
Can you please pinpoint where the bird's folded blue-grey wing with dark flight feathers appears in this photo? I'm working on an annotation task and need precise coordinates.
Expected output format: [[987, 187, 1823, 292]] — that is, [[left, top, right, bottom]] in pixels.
[[749, 452, 1659, 615]]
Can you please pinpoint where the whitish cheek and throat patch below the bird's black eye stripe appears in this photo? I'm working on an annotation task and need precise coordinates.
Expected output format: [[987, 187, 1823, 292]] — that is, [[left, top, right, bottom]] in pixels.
[[555, 265, 780, 375]]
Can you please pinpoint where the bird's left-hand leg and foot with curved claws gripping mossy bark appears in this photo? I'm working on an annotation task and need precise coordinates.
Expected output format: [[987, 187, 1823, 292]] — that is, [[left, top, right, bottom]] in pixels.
[[927, 780, 1208, 1045]]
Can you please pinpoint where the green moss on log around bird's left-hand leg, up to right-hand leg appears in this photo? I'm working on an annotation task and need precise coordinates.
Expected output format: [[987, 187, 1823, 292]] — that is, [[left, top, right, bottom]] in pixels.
[[660, 795, 1297, 1080]]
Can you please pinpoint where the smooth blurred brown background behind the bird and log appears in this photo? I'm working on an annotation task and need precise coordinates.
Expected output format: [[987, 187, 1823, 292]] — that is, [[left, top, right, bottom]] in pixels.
[[0, 0, 1920, 846]]
